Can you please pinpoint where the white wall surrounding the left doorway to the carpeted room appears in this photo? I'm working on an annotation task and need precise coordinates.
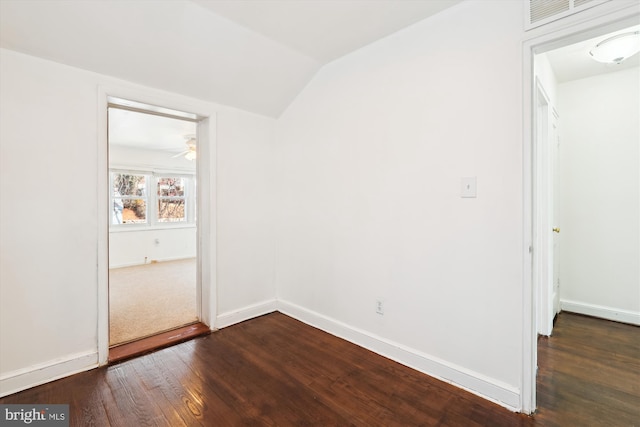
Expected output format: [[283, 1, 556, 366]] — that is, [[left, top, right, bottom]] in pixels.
[[0, 49, 274, 394]]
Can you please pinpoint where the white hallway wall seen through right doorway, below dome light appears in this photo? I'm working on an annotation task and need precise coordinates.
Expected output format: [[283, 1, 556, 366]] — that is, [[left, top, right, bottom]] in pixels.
[[558, 68, 640, 324]]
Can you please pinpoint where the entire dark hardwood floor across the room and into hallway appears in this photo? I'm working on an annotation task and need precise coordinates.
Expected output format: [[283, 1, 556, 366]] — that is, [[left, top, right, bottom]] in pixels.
[[0, 313, 640, 427]]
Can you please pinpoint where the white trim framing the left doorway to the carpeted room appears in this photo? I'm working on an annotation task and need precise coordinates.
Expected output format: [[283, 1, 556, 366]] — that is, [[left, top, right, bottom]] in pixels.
[[96, 85, 217, 366]]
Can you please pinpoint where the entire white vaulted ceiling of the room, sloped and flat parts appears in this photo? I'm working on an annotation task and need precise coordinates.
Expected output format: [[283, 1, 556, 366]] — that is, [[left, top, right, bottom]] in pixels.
[[0, 0, 461, 117]]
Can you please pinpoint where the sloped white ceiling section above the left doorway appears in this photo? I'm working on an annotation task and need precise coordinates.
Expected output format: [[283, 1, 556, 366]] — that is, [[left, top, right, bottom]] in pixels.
[[0, 0, 320, 117]]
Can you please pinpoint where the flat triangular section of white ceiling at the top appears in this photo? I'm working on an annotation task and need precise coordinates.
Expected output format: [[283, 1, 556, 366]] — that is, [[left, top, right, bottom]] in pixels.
[[194, 0, 462, 63]]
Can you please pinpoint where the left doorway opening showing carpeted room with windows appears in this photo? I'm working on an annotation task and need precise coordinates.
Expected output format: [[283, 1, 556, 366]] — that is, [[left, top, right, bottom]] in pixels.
[[107, 98, 209, 362]]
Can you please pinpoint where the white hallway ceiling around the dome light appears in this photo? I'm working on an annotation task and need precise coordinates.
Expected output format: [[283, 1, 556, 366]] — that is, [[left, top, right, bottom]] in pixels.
[[546, 25, 640, 83]]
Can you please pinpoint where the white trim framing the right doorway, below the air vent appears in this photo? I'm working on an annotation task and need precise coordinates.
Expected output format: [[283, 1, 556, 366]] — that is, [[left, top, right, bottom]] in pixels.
[[520, 2, 640, 414]]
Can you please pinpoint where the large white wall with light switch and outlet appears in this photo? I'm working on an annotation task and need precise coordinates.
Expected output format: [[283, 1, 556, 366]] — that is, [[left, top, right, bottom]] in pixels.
[[276, 1, 523, 408]]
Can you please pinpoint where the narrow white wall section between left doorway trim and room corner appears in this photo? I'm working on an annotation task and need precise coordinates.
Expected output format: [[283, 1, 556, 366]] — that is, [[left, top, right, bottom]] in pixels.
[[217, 111, 276, 318]]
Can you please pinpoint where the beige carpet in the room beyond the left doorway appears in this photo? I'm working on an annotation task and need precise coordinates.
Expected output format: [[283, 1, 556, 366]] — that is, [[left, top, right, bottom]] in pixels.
[[109, 258, 198, 346]]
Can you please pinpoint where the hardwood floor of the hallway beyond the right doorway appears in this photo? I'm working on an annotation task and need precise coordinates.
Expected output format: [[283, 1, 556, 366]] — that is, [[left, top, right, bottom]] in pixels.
[[535, 312, 640, 427]]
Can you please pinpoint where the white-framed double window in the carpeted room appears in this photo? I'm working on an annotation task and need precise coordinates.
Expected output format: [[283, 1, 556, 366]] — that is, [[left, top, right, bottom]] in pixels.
[[110, 170, 195, 226]]
